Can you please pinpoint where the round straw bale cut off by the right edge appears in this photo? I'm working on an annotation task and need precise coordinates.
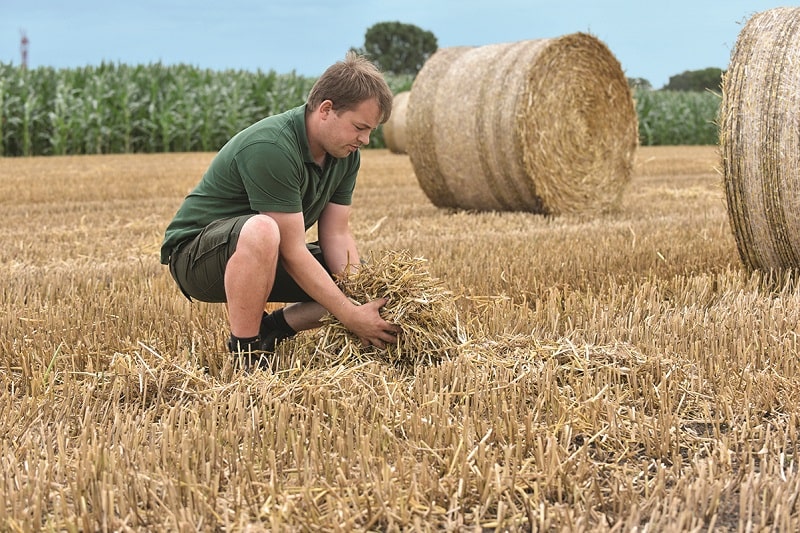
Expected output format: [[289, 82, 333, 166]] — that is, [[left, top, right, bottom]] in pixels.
[[719, 8, 800, 270]]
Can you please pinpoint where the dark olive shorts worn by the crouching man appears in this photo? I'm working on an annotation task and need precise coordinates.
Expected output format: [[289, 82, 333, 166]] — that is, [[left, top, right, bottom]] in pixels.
[[169, 215, 330, 303]]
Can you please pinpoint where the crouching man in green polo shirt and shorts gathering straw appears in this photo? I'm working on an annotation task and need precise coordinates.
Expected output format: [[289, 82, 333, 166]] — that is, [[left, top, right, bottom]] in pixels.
[[161, 52, 399, 368]]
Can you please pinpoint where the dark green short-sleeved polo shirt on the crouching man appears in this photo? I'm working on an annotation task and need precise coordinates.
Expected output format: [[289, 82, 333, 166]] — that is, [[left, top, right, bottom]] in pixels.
[[161, 105, 361, 264]]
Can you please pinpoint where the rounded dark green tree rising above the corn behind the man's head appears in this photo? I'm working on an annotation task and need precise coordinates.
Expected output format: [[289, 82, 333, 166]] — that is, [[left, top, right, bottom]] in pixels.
[[355, 22, 438, 75]]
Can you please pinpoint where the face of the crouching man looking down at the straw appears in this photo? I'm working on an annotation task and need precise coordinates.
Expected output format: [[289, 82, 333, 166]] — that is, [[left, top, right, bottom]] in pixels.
[[323, 98, 381, 158]]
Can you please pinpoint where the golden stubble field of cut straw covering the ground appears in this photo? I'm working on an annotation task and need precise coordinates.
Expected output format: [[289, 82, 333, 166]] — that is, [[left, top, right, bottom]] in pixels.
[[0, 143, 800, 531]]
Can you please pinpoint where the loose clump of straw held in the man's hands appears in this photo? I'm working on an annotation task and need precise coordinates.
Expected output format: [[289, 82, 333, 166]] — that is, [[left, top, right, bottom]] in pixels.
[[316, 252, 465, 366]]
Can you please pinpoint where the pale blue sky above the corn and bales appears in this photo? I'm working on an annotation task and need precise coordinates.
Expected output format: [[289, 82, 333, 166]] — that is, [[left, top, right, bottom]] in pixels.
[[0, 0, 787, 88]]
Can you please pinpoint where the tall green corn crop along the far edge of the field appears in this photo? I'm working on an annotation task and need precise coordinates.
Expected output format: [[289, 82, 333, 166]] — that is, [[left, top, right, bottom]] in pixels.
[[0, 63, 719, 156]]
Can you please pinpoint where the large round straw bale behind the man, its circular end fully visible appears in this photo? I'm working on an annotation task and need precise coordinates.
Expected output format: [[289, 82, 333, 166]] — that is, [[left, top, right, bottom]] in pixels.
[[406, 33, 639, 214]]
